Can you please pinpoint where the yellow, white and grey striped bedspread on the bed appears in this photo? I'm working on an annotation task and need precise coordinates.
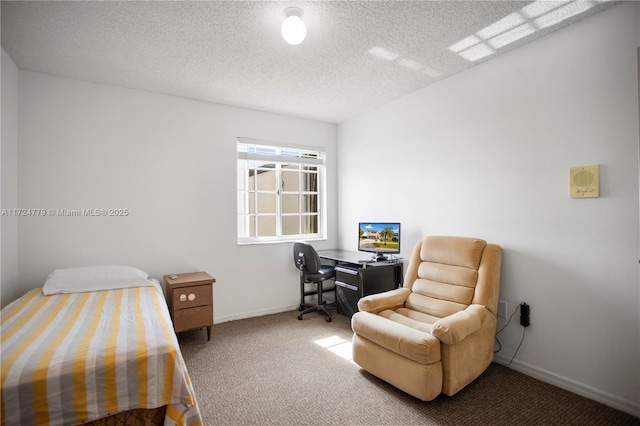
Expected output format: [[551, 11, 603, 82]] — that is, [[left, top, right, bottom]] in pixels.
[[0, 285, 202, 426]]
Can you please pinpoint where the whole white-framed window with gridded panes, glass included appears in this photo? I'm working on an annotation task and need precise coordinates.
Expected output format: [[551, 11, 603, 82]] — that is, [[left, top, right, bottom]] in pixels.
[[238, 138, 325, 244]]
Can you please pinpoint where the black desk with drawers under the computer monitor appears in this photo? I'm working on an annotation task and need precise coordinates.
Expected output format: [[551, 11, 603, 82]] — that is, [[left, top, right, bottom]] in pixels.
[[318, 249, 403, 317]]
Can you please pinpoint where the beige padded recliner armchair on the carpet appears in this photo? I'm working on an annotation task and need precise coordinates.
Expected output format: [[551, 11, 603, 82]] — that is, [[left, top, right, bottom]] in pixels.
[[351, 236, 502, 401]]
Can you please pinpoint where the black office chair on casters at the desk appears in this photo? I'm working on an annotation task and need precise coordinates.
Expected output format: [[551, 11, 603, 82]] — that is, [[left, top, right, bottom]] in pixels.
[[293, 242, 336, 322]]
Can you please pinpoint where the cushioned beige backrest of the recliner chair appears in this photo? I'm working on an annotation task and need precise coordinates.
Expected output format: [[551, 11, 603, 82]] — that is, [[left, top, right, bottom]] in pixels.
[[404, 236, 487, 318]]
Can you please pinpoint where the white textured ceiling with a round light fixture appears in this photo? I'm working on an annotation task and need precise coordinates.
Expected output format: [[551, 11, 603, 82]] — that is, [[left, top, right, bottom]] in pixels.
[[1, 0, 614, 123]]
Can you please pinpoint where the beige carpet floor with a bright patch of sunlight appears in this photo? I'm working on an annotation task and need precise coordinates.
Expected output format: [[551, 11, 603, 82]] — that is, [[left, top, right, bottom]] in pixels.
[[179, 311, 640, 425]]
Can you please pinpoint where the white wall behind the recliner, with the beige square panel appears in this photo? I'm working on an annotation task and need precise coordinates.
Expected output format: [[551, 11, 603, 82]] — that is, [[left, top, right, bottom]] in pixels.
[[338, 3, 640, 415]]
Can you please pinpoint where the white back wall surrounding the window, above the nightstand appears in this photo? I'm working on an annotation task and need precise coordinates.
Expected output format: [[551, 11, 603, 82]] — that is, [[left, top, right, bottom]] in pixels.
[[18, 71, 337, 322]]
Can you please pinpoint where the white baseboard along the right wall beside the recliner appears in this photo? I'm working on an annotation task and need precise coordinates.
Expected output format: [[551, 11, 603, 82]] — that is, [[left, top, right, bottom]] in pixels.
[[494, 354, 640, 417]]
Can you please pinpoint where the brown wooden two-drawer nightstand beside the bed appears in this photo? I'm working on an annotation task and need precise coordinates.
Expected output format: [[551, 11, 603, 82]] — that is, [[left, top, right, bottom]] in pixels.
[[164, 272, 216, 341]]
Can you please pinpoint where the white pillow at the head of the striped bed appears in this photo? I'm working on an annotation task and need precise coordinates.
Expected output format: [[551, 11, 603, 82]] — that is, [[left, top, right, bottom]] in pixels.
[[42, 265, 155, 296]]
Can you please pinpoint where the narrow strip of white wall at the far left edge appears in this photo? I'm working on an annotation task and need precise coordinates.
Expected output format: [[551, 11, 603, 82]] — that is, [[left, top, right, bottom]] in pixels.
[[0, 49, 22, 307]]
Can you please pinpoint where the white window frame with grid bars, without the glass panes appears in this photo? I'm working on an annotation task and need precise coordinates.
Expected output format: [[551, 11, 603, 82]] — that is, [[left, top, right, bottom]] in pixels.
[[236, 137, 327, 245]]
